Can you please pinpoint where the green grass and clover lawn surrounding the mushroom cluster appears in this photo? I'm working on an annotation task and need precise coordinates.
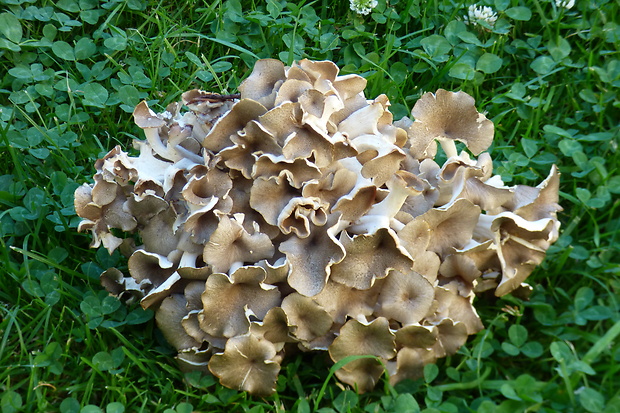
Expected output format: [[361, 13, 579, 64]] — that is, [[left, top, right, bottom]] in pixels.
[[0, 0, 620, 413]]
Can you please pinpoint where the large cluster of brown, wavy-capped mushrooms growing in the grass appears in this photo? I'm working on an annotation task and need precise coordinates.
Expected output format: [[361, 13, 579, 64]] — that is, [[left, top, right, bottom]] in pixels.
[[75, 59, 561, 395]]
